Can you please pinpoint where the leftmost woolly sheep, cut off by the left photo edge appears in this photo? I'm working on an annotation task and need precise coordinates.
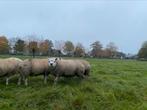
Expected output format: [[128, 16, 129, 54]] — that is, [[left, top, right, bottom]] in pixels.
[[0, 57, 22, 85]]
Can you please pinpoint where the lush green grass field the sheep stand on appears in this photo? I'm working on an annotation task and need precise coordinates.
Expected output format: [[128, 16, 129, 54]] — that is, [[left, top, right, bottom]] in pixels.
[[0, 55, 147, 110]]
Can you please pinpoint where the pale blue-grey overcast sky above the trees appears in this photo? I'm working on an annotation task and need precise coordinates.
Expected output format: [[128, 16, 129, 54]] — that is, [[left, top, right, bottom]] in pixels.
[[0, 0, 147, 53]]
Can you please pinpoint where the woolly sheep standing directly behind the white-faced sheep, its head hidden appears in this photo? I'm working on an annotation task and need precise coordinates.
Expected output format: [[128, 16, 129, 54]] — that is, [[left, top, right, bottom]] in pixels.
[[18, 59, 50, 86]]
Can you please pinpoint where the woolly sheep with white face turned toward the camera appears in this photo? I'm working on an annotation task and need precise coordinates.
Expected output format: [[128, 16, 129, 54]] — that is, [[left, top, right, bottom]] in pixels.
[[48, 59, 85, 84]]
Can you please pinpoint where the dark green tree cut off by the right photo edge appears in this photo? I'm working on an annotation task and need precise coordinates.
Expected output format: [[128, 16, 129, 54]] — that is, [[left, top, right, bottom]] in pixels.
[[138, 41, 147, 58]]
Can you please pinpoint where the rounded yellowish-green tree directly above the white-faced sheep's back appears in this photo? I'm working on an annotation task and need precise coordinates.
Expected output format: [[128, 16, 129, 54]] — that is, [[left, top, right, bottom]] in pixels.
[[64, 41, 74, 56]]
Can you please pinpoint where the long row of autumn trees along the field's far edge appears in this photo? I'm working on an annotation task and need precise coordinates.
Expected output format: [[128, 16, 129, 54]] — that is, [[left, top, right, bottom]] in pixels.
[[0, 35, 146, 58]]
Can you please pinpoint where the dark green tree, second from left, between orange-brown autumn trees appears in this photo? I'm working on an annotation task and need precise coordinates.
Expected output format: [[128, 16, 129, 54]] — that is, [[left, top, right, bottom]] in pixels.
[[14, 39, 25, 54]]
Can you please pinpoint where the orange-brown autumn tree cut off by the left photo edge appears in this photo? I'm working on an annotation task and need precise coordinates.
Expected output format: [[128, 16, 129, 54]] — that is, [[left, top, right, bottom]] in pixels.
[[0, 36, 9, 54]]
